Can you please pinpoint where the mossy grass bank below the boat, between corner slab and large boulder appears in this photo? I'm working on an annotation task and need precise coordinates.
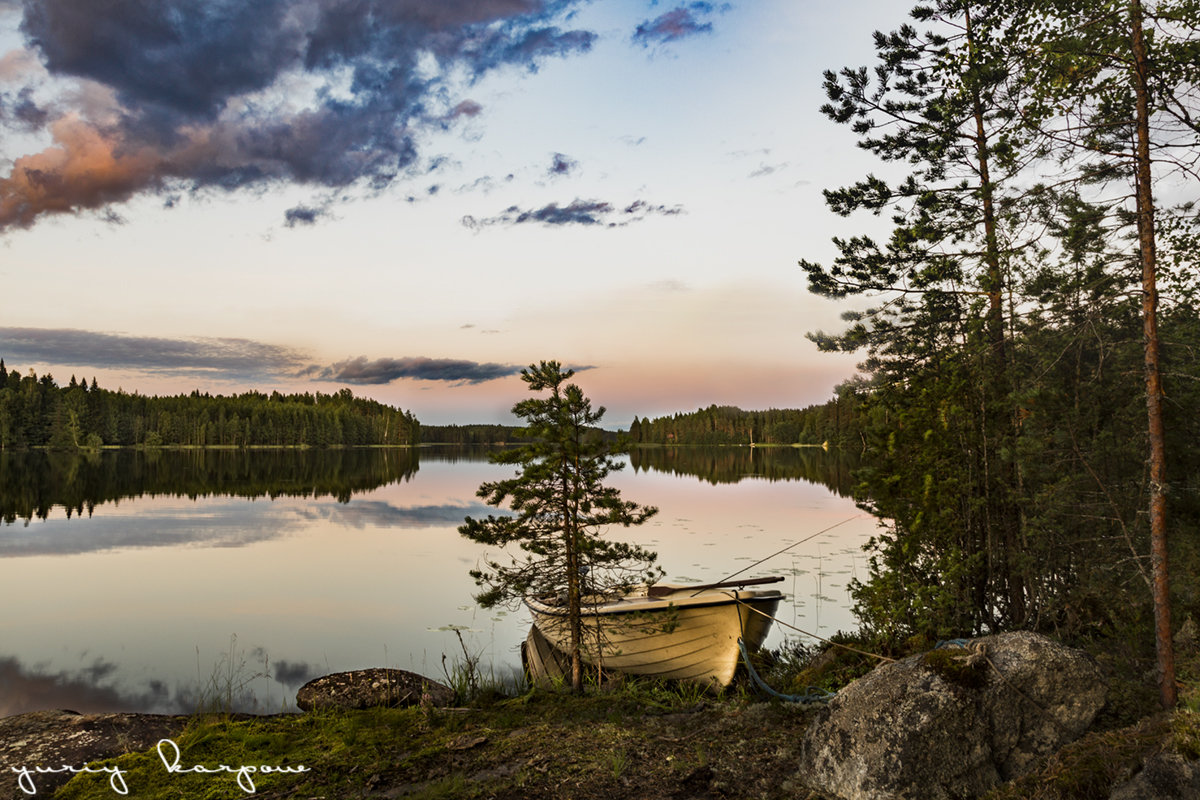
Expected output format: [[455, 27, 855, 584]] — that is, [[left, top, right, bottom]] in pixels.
[[55, 687, 825, 800]]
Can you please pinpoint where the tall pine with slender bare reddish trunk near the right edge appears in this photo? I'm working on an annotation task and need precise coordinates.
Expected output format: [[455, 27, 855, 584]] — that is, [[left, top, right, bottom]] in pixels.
[[1004, 0, 1200, 708]]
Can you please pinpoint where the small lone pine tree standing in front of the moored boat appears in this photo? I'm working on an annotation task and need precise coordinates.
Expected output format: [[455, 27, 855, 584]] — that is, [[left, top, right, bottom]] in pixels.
[[458, 361, 661, 691]]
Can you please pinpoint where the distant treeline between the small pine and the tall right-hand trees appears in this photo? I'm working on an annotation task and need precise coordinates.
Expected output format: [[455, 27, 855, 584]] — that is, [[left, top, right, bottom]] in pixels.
[[629, 396, 860, 446]]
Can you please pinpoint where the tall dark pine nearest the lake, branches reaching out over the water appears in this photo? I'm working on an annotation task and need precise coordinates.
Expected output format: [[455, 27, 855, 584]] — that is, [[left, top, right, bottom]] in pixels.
[[800, 0, 1046, 631]]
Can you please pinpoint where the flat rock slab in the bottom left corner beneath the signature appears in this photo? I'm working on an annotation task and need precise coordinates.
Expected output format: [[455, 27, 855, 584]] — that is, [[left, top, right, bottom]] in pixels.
[[0, 711, 187, 798]]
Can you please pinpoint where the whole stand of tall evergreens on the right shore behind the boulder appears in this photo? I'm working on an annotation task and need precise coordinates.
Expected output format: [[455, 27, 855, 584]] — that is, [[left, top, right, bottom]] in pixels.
[[800, 0, 1200, 706]]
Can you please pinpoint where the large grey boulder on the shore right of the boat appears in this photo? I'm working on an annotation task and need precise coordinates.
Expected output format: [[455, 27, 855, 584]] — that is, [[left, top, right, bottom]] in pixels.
[[798, 632, 1105, 800]]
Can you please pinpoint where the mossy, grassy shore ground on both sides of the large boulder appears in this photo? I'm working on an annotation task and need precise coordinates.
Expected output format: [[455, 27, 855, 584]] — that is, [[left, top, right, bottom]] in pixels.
[[54, 633, 1200, 800]]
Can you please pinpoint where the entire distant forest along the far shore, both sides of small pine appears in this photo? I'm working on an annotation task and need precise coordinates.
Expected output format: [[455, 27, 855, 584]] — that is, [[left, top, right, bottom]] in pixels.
[[0, 359, 860, 450]]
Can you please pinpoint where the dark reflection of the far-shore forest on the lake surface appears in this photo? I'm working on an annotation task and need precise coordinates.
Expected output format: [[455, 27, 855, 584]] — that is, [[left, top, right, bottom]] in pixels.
[[0, 446, 856, 527]]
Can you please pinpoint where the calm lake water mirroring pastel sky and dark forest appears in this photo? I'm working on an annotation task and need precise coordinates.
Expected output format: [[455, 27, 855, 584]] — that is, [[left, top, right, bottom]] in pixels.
[[0, 447, 875, 716]]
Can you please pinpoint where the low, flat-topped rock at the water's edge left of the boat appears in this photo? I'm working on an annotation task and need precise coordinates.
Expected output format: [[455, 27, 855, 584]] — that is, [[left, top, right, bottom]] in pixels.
[[296, 668, 454, 711]]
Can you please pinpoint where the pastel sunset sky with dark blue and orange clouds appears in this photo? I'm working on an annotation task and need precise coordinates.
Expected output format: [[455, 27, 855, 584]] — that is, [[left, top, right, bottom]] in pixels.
[[0, 0, 907, 426]]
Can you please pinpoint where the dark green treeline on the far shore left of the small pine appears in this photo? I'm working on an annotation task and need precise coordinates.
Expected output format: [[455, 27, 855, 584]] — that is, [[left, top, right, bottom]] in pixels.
[[0, 360, 420, 450]]
